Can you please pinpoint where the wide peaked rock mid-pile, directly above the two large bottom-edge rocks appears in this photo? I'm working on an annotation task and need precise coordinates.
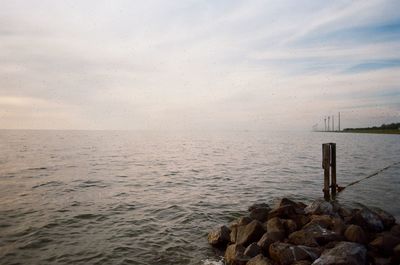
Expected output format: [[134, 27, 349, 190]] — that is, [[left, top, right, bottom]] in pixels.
[[289, 224, 343, 247]]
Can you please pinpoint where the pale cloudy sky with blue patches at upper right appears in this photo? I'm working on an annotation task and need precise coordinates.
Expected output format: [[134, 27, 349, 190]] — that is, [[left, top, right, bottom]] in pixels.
[[0, 0, 400, 130]]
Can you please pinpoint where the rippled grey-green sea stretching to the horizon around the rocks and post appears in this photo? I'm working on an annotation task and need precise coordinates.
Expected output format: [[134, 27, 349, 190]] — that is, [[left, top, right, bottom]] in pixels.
[[0, 130, 400, 265]]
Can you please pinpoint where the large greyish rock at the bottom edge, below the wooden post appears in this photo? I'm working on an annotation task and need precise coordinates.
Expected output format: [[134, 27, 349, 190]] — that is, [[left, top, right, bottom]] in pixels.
[[312, 242, 367, 265]]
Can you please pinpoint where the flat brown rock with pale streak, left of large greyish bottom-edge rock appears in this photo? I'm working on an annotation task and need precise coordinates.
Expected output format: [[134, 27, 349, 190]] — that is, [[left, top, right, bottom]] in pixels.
[[269, 242, 320, 265]]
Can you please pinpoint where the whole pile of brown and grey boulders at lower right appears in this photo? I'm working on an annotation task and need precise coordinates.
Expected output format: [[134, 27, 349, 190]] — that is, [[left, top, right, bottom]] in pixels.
[[208, 198, 400, 265]]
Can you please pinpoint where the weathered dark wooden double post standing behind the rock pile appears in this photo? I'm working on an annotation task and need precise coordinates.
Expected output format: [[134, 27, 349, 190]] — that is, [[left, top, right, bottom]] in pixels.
[[322, 143, 337, 200]]
